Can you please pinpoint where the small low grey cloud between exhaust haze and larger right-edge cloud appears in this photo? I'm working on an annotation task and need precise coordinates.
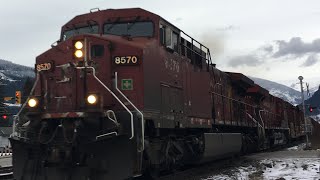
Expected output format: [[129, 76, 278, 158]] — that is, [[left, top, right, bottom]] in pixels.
[[228, 55, 263, 67]]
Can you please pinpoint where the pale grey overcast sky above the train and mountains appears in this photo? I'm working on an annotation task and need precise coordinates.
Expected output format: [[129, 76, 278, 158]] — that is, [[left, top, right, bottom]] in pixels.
[[0, 0, 320, 82]]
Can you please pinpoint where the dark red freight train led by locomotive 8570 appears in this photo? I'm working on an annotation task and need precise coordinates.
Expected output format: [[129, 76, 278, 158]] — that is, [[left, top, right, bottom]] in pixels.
[[10, 8, 301, 180]]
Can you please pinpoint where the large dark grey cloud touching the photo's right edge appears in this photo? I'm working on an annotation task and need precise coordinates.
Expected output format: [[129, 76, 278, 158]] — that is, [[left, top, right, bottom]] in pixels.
[[273, 37, 320, 58]]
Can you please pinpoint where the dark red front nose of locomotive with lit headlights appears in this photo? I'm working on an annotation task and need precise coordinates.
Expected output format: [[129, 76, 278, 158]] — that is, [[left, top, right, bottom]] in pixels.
[[33, 35, 112, 113]]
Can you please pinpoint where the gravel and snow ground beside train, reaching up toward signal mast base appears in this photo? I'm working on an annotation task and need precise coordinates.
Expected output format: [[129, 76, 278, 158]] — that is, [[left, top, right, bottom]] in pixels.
[[199, 143, 320, 180]]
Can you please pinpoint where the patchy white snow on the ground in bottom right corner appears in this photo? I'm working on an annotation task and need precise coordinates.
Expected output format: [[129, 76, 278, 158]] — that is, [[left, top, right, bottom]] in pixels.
[[202, 158, 320, 180]]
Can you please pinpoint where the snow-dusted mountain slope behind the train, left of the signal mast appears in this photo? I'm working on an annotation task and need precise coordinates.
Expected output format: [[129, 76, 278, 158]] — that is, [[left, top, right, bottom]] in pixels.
[[250, 77, 307, 105]]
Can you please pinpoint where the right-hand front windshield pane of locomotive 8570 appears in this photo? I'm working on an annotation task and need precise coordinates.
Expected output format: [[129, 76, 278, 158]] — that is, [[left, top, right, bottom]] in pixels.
[[104, 22, 153, 37]]
